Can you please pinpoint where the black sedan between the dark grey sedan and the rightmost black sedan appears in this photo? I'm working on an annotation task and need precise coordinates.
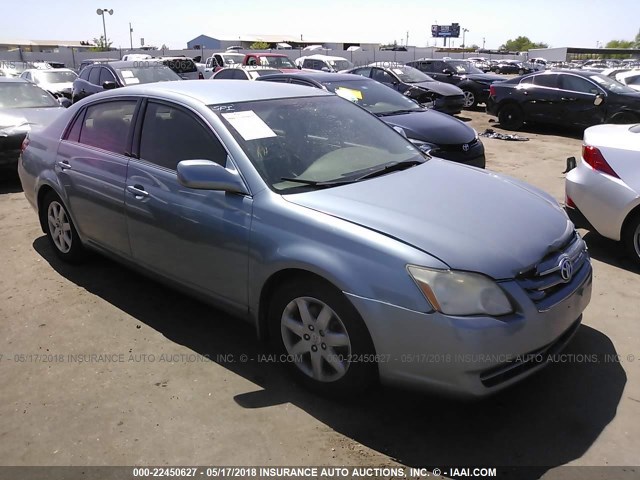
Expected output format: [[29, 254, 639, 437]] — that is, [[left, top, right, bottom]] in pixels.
[[407, 58, 504, 108]]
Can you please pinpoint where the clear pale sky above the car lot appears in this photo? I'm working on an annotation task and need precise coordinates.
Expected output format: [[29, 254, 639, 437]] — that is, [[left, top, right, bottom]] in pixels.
[[0, 0, 640, 49]]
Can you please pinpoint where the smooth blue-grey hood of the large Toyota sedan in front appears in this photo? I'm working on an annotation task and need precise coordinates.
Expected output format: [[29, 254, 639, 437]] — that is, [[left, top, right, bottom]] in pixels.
[[284, 159, 574, 279]]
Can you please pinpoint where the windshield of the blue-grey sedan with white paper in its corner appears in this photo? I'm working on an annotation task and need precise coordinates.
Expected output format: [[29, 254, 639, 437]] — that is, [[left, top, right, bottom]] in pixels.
[[210, 95, 425, 194]]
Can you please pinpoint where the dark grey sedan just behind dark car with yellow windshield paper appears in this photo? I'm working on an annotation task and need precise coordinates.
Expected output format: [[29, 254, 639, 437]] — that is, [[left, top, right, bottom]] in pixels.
[[346, 62, 464, 115]]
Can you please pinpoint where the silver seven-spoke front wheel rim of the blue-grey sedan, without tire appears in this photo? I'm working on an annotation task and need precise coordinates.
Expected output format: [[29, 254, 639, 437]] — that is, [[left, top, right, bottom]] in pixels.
[[280, 297, 351, 382]]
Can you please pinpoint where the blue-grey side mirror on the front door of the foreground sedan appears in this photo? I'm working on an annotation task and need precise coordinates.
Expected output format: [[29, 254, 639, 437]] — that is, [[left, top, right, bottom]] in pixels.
[[177, 160, 249, 194]]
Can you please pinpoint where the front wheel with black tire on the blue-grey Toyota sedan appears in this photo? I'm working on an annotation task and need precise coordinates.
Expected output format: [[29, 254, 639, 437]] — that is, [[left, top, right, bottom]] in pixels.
[[268, 277, 378, 398]]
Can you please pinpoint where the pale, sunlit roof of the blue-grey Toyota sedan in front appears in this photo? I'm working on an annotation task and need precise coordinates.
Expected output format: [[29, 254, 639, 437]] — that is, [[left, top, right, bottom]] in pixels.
[[99, 80, 330, 105]]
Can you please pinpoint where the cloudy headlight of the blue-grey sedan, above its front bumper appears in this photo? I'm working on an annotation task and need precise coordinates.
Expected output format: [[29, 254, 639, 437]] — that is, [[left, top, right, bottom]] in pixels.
[[407, 265, 513, 316]]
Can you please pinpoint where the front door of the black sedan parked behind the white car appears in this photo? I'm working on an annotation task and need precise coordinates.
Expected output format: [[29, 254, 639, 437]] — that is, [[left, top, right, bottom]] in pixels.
[[559, 74, 606, 126]]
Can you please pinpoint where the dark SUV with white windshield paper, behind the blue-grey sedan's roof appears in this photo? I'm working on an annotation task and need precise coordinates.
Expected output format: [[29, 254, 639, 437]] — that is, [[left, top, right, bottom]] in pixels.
[[71, 60, 181, 103]]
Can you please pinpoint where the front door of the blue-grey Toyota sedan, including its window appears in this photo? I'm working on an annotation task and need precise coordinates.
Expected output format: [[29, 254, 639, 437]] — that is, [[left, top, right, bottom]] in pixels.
[[125, 100, 252, 308]]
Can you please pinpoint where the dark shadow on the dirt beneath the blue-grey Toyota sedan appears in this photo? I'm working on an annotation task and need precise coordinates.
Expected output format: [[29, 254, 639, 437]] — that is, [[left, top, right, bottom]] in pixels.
[[33, 237, 626, 480]]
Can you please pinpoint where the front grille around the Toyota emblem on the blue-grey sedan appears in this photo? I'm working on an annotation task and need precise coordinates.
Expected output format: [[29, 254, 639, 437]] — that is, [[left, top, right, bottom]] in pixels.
[[516, 232, 591, 311]]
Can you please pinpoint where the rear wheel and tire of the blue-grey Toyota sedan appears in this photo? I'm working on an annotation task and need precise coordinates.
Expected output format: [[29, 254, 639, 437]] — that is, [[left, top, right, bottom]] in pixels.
[[40, 191, 85, 263]]
